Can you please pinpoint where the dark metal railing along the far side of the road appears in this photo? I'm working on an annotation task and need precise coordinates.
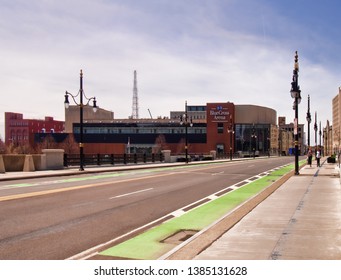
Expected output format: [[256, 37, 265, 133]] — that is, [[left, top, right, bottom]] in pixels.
[[64, 153, 164, 167]]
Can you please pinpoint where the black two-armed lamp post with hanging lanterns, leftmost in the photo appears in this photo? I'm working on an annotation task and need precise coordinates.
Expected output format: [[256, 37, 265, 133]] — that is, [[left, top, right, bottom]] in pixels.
[[64, 70, 97, 171]]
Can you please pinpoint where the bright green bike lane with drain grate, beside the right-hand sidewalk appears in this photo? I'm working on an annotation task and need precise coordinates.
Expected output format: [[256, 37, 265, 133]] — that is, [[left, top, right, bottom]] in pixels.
[[95, 164, 294, 260]]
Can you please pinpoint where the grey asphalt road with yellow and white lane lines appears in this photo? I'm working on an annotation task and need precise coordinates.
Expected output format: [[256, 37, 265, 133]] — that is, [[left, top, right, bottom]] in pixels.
[[0, 157, 294, 260]]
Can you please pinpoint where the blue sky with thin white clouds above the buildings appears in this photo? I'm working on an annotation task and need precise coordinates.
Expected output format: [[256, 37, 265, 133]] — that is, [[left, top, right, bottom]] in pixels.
[[0, 0, 341, 139]]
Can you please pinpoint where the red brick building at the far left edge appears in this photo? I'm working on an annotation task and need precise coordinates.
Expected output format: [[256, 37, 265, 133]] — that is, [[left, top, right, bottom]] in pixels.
[[5, 112, 64, 146]]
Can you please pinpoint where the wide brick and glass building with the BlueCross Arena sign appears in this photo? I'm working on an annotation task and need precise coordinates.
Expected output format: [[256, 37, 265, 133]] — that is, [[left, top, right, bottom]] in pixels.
[[47, 102, 286, 156]]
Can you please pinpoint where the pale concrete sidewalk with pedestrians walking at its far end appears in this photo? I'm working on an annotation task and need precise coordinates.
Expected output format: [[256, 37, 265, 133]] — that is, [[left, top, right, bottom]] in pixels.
[[194, 159, 341, 260]]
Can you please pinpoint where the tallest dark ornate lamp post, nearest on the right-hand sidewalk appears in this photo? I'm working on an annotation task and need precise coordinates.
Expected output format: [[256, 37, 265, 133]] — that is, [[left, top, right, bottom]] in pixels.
[[290, 51, 302, 175]]
